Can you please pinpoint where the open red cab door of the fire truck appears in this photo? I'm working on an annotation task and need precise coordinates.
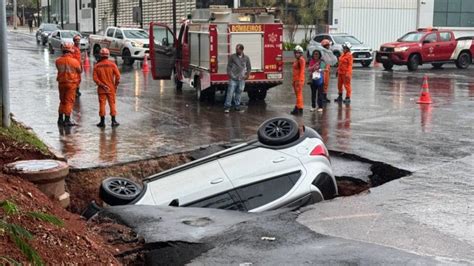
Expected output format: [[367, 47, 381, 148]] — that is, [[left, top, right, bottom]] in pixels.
[[149, 22, 177, 79]]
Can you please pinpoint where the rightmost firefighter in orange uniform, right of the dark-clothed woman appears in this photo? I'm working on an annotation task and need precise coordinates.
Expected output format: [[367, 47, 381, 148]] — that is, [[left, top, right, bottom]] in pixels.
[[335, 42, 352, 104]]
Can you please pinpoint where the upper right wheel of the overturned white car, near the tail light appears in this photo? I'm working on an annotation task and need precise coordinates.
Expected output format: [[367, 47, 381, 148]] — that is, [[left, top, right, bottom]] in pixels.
[[257, 117, 300, 146]]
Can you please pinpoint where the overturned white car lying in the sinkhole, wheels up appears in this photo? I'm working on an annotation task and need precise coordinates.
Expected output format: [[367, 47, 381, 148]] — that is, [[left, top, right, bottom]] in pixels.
[[100, 118, 337, 212]]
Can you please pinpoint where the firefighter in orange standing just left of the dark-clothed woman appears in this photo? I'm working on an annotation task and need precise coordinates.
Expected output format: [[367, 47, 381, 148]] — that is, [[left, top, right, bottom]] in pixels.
[[290, 45, 306, 115]]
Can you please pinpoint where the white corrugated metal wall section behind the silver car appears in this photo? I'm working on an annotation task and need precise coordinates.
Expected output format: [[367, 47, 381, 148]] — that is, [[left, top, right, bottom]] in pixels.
[[336, 0, 417, 50]]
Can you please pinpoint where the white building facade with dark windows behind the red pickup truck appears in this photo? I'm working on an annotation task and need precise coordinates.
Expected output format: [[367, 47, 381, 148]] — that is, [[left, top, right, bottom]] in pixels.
[[329, 0, 474, 50]]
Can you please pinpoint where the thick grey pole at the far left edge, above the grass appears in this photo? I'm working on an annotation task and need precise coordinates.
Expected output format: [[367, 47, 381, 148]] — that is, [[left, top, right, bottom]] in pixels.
[[0, 1, 10, 127]]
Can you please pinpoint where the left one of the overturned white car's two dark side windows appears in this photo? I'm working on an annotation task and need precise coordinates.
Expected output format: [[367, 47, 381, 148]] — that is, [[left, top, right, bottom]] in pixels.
[[185, 191, 246, 211]]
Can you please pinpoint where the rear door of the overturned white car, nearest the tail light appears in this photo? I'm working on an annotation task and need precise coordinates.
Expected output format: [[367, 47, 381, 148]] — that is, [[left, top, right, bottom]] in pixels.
[[219, 148, 310, 211]]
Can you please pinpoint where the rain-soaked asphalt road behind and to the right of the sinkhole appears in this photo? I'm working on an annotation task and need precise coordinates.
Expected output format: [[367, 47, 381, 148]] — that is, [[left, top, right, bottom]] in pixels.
[[4, 30, 474, 265]]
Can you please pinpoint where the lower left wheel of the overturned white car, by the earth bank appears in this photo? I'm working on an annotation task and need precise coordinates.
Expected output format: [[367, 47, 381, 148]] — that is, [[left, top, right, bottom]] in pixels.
[[99, 177, 142, 206]]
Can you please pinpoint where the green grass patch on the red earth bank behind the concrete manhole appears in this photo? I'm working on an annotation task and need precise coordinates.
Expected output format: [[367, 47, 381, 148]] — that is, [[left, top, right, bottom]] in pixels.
[[0, 121, 50, 155]]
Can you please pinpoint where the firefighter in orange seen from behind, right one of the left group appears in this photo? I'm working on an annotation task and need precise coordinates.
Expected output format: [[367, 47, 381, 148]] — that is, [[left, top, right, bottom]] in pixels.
[[94, 48, 120, 128]]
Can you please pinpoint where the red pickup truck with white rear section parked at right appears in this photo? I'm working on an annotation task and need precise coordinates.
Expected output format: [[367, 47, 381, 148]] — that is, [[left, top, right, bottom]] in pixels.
[[376, 29, 474, 71]]
